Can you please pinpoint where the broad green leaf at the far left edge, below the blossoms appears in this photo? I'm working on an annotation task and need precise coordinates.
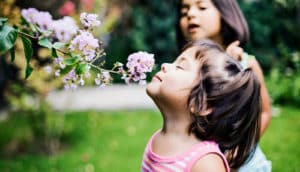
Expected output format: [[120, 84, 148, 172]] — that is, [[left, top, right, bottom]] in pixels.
[[0, 24, 18, 53]]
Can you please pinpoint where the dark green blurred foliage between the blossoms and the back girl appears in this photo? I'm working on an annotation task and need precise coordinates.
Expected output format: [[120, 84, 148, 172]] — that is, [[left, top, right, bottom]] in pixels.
[[106, 0, 176, 66]]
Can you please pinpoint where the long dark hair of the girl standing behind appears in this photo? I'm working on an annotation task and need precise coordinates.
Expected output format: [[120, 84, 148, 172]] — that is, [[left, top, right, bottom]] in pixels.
[[176, 0, 249, 49]]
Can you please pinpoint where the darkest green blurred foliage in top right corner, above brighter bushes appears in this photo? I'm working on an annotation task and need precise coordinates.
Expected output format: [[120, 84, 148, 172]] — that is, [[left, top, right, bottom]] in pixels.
[[239, 0, 300, 69]]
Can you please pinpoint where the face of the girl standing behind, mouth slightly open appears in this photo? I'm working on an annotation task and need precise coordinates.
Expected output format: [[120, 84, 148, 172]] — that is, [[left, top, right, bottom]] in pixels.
[[179, 0, 221, 42]]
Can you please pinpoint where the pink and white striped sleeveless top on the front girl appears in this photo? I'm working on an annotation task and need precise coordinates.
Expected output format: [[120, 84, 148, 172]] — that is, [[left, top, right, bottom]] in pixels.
[[142, 132, 230, 172]]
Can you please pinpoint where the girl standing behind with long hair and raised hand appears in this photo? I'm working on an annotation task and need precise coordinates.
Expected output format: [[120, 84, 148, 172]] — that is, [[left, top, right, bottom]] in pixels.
[[177, 0, 271, 171]]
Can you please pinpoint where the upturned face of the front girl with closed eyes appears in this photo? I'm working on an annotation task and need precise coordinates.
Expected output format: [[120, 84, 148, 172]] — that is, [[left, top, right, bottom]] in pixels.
[[147, 47, 200, 107]]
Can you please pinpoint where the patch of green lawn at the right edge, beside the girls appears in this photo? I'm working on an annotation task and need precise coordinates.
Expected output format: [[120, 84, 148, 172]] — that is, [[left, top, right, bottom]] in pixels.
[[260, 107, 300, 172]]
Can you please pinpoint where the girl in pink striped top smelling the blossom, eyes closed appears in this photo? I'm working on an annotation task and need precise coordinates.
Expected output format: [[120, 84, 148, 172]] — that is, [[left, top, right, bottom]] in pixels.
[[142, 40, 261, 172]]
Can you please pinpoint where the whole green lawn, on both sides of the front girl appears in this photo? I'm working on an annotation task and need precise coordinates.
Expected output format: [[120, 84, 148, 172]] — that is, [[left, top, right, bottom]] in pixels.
[[0, 107, 300, 172]]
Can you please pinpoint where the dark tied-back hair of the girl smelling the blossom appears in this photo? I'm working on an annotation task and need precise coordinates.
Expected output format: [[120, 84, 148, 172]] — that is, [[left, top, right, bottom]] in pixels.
[[184, 40, 261, 169]]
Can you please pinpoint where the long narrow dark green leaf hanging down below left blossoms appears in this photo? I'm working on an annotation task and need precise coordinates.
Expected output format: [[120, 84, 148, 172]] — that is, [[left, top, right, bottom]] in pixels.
[[21, 36, 33, 78]]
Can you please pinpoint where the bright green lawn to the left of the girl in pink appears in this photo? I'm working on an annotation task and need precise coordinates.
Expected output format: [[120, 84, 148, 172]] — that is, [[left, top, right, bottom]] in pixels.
[[0, 110, 161, 172]]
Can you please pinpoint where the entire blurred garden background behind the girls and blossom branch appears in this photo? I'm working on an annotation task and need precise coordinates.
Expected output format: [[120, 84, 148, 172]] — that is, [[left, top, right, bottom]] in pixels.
[[0, 0, 300, 172]]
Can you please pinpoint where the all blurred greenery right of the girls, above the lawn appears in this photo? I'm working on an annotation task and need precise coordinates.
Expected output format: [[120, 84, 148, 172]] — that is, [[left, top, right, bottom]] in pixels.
[[240, 0, 300, 106]]
